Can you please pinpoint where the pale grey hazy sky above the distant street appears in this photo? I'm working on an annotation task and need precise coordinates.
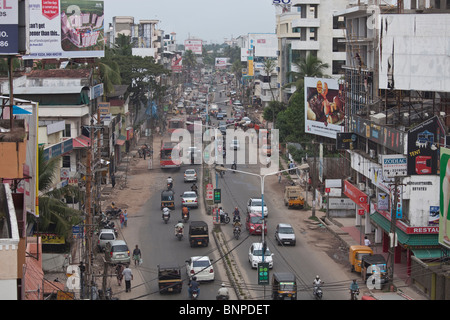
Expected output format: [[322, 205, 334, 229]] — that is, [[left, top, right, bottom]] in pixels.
[[104, 0, 276, 44]]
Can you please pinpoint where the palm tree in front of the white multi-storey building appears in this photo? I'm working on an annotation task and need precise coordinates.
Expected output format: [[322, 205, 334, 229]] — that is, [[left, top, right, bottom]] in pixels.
[[283, 54, 329, 95]]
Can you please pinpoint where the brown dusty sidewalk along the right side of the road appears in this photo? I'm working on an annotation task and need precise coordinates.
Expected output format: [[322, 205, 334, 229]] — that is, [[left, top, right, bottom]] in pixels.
[[280, 157, 429, 300]]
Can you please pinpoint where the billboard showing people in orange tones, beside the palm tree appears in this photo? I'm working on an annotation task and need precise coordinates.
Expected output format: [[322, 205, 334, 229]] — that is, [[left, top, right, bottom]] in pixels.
[[304, 77, 345, 139]]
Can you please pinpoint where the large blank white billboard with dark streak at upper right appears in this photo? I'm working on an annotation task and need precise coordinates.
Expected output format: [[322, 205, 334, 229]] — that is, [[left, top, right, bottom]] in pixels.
[[378, 14, 450, 92]]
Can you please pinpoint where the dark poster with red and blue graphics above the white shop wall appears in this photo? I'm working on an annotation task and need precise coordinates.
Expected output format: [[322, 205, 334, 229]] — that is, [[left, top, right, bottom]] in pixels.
[[408, 117, 445, 175]]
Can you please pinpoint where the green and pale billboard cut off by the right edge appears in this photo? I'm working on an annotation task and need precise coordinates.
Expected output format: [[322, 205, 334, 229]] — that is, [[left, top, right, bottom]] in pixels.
[[439, 148, 450, 249]]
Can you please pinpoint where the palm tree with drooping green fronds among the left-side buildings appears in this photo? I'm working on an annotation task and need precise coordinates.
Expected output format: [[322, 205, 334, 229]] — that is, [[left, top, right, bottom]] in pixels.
[[32, 148, 82, 239]]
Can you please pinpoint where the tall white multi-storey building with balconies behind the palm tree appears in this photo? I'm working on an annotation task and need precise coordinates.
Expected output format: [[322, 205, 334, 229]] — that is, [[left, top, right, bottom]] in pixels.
[[276, 0, 348, 101]]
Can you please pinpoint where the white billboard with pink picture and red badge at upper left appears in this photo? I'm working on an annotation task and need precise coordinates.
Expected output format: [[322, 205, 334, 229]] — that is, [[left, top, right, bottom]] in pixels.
[[23, 0, 105, 59]]
